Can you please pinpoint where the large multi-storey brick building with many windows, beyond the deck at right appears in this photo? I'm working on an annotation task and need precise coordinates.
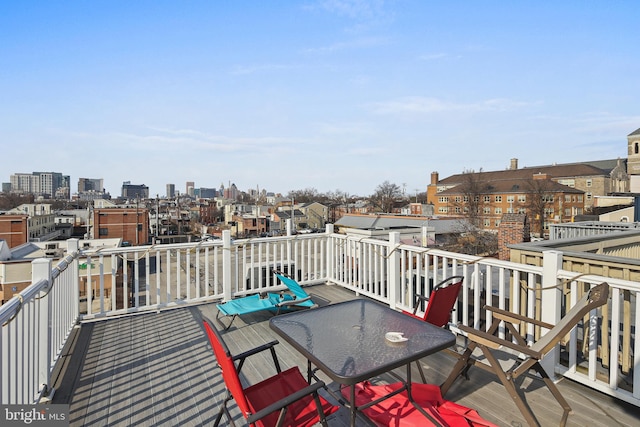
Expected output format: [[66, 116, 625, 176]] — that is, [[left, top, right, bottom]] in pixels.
[[427, 159, 604, 235]]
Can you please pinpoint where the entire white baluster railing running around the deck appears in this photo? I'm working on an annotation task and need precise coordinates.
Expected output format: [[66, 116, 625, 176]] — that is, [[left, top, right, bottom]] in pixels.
[[0, 225, 640, 406]]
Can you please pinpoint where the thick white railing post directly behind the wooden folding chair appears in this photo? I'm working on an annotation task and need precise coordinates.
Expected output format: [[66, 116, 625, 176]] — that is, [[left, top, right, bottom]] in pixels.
[[540, 251, 562, 379]]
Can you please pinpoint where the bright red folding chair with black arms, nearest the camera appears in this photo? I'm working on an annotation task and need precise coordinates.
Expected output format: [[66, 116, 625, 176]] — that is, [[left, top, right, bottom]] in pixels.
[[203, 318, 338, 427]]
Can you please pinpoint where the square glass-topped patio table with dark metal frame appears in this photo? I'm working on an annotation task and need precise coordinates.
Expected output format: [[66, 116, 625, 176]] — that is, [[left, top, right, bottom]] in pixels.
[[269, 299, 455, 426]]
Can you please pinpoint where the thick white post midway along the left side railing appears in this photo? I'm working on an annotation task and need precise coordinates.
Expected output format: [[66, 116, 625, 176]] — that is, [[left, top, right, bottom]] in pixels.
[[31, 258, 53, 402]]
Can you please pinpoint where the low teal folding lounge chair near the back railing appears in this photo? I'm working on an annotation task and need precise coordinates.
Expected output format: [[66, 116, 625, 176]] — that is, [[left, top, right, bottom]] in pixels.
[[216, 270, 316, 329]]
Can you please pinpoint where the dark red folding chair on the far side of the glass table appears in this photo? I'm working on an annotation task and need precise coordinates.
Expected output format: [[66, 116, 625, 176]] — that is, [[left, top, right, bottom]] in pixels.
[[404, 276, 464, 383]]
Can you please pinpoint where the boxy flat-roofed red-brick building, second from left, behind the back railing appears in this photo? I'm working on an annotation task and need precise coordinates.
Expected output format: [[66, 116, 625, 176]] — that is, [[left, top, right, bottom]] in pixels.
[[93, 208, 149, 246]]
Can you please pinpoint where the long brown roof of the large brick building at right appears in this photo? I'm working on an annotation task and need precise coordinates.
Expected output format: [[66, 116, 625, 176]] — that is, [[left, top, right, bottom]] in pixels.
[[438, 161, 617, 185]]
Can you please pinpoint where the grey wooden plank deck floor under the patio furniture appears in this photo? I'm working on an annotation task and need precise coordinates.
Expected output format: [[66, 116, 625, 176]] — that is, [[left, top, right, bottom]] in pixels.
[[54, 285, 640, 427]]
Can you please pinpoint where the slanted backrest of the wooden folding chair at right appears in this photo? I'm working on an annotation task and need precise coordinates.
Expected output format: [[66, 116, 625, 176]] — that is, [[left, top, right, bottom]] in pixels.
[[531, 282, 609, 355]]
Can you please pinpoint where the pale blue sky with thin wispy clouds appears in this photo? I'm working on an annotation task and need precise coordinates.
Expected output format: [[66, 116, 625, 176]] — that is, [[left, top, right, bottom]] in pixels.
[[0, 0, 640, 196]]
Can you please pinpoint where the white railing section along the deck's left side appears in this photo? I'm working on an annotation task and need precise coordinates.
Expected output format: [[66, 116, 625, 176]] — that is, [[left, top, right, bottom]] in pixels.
[[0, 240, 79, 405]]
